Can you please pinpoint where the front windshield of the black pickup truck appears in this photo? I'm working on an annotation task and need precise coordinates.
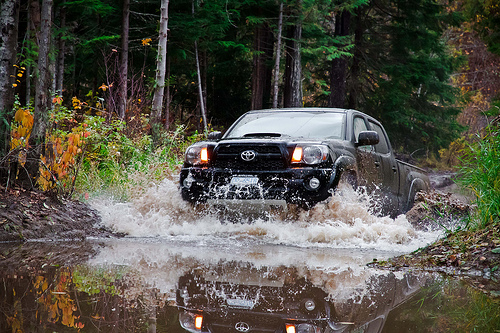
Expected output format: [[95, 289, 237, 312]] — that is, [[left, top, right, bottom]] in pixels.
[[225, 111, 345, 139]]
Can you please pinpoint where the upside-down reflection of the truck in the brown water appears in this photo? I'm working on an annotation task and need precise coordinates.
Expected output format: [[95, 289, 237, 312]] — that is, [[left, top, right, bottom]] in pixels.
[[176, 267, 422, 333]]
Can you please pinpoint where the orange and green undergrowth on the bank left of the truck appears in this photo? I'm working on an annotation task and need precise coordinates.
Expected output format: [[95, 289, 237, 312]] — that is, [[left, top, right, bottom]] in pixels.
[[7, 97, 203, 200]]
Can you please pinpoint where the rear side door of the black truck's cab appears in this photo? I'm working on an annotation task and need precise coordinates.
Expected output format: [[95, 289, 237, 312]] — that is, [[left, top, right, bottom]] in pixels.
[[368, 119, 399, 207]]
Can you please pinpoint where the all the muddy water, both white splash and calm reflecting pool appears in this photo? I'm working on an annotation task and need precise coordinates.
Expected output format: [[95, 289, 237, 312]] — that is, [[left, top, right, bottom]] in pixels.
[[0, 181, 498, 333]]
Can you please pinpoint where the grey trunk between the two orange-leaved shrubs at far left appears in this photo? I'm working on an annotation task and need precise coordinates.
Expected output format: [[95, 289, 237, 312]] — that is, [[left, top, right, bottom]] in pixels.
[[26, 0, 52, 185]]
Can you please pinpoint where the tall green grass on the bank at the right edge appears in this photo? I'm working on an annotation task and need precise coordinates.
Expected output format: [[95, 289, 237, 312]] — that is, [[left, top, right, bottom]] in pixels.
[[459, 118, 500, 228]]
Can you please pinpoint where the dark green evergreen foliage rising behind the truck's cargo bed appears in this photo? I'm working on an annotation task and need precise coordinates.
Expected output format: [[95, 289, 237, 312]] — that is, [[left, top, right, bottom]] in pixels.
[[351, 0, 463, 153]]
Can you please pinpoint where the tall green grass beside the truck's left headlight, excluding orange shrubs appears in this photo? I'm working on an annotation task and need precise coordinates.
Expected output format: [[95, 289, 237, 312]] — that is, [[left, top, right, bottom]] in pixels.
[[76, 122, 201, 201]]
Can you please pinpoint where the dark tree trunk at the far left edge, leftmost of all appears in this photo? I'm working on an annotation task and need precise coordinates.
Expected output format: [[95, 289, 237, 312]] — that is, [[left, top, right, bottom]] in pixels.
[[0, 0, 20, 156]]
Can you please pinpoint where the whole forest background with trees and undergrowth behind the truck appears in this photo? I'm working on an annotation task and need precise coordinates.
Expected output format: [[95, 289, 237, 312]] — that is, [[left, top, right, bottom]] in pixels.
[[0, 0, 500, 228]]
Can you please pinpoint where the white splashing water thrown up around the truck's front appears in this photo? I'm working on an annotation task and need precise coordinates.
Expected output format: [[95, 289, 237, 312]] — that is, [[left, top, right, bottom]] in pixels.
[[92, 179, 442, 252]]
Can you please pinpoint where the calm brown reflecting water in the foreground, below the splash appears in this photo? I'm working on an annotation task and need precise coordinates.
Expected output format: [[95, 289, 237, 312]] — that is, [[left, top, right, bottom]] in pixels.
[[0, 239, 500, 333]]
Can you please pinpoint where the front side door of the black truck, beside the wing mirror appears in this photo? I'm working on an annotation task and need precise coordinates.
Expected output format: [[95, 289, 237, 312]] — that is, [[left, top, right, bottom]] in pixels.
[[353, 116, 382, 192]]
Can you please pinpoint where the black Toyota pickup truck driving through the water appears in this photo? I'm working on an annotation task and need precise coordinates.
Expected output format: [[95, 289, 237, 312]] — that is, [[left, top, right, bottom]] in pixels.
[[180, 108, 429, 216]]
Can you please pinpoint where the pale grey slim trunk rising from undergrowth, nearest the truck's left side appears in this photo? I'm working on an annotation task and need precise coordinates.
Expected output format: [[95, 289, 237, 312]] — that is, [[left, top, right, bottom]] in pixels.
[[151, 0, 169, 144]]
